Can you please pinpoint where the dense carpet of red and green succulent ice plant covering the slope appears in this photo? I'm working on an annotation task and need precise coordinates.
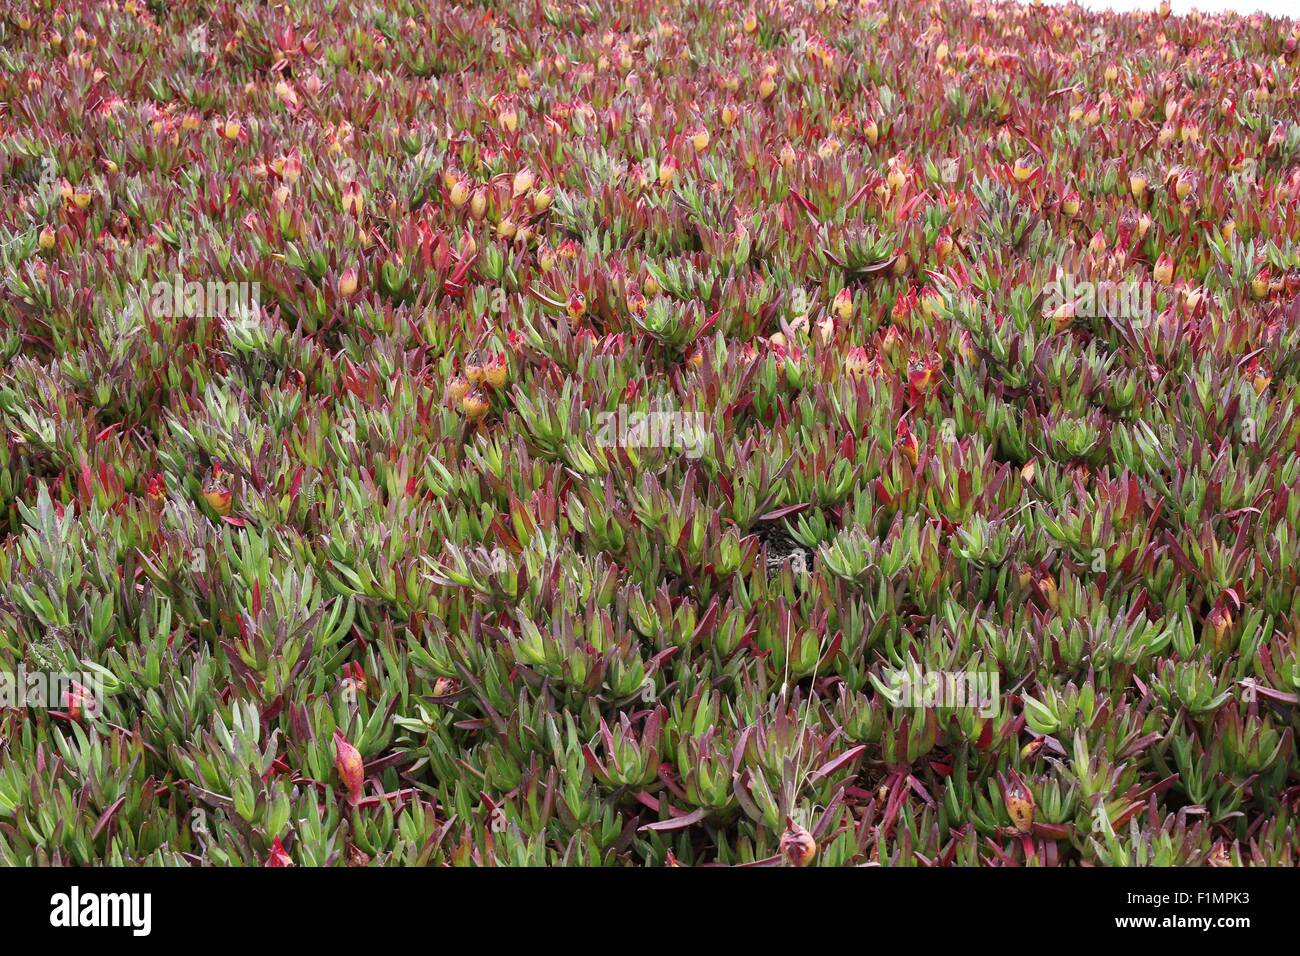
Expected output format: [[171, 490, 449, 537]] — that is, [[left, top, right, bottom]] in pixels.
[[0, 0, 1300, 865]]
